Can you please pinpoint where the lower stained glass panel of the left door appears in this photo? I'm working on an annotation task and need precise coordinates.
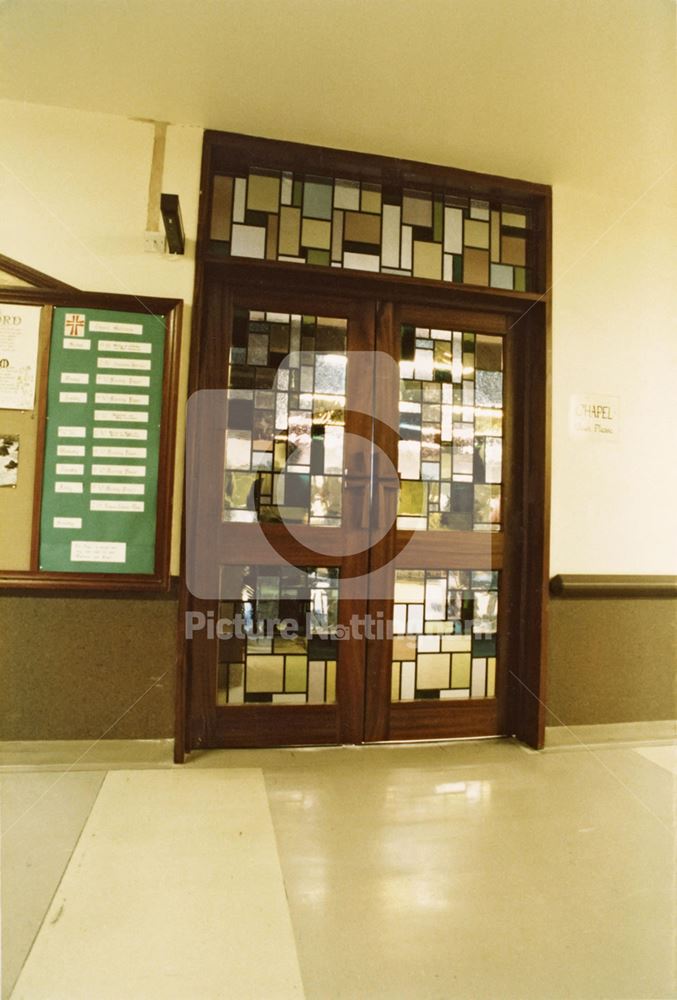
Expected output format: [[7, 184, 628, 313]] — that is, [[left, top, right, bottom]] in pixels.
[[215, 566, 339, 705]]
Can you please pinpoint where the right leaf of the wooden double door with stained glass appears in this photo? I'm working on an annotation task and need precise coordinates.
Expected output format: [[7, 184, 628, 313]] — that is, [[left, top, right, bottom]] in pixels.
[[365, 306, 512, 740]]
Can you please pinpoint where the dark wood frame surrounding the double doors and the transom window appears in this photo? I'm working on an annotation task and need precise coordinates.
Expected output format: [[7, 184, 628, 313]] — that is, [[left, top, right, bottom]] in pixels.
[[175, 131, 552, 761]]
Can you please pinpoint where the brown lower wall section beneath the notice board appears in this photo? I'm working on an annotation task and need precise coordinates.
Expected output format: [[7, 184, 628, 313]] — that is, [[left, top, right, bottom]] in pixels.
[[0, 595, 178, 740]]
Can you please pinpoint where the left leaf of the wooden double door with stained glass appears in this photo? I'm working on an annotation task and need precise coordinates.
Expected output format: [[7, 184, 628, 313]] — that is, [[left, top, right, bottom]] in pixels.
[[189, 285, 374, 747]]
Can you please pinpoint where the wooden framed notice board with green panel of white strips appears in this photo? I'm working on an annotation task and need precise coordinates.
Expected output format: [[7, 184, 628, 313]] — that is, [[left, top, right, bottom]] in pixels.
[[0, 289, 182, 590]]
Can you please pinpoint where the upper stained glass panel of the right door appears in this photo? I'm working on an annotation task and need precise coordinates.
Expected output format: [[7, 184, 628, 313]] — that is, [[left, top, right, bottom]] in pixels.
[[397, 324, 503, 531]]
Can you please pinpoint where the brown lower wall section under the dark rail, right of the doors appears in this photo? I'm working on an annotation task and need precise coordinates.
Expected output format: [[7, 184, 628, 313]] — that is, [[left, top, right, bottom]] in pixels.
[[546, 597, 677, 726]]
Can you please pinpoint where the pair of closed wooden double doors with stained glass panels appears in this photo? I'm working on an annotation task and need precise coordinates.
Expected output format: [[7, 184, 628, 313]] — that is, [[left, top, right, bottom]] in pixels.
[[179, 281, 525, 749]]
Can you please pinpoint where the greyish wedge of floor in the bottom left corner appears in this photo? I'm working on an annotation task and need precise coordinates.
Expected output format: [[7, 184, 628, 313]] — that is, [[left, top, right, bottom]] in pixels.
[[0, 772, 104, 1000]]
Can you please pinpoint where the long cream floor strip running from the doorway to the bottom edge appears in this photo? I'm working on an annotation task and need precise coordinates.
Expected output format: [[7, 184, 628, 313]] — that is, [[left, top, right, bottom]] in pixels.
[[12, 769, 303, 1000]]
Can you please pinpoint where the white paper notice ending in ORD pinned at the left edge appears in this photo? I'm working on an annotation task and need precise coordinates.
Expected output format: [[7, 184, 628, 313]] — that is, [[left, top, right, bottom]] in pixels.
[[0, 303, 41, 410]]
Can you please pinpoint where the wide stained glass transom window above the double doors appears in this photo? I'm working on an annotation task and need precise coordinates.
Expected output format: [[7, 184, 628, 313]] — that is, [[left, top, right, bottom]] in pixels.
[[210, 168, 532, 291]]
